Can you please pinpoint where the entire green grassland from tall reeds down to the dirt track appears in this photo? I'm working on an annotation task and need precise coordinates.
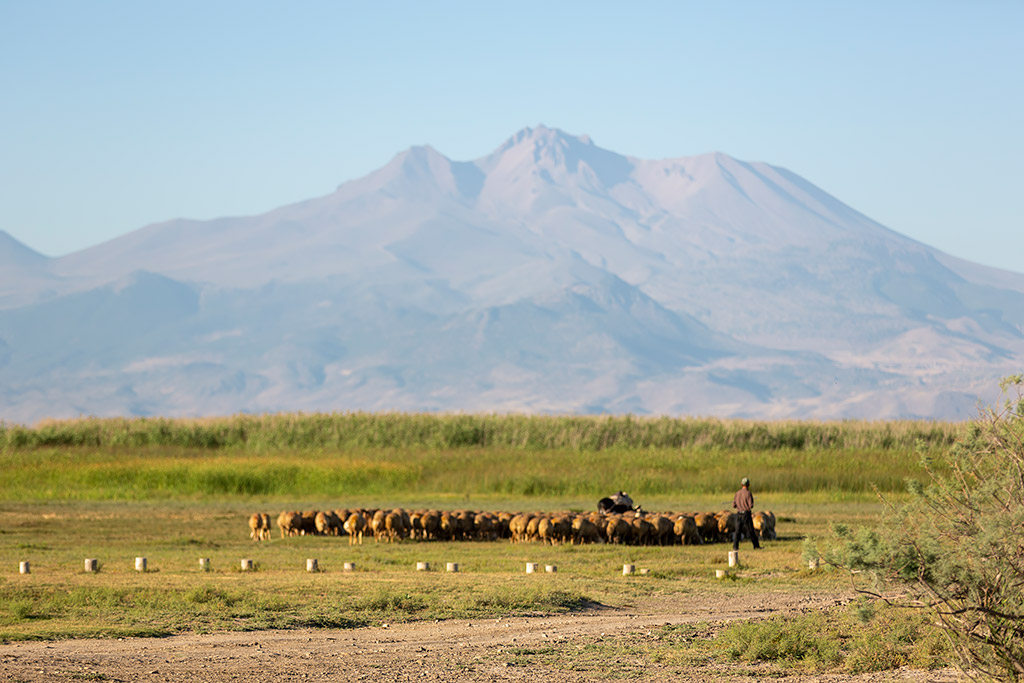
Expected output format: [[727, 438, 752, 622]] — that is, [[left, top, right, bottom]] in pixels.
[[0, 415, 950, 675]]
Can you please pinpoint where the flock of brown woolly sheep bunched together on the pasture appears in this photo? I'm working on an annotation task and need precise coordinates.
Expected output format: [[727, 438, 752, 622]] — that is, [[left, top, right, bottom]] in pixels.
[[249, 509, 775, 546]]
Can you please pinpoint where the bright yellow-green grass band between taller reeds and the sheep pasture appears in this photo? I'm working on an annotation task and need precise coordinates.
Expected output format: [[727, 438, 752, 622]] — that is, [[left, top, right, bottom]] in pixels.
[[0, 446, 937, 507]]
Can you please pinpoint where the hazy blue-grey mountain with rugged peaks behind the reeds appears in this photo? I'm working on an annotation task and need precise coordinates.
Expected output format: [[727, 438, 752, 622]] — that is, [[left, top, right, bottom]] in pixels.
[[0, 126, 1024, 422]]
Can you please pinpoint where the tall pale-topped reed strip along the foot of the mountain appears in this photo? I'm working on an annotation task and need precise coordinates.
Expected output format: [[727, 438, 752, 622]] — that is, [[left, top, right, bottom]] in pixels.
[[0, 413, 966, 452]]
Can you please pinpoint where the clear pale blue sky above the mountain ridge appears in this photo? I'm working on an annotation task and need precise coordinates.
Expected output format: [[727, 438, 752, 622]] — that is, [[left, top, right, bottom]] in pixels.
[[6, 0, 1024, 272]]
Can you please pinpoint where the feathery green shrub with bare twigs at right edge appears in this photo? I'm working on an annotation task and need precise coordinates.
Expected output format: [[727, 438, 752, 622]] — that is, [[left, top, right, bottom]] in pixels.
[[824, 376, 1024, 681]]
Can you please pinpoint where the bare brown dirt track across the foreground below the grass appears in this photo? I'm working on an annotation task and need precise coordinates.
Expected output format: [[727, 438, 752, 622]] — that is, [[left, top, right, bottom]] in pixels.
[[0, 593, 958, 683]]
